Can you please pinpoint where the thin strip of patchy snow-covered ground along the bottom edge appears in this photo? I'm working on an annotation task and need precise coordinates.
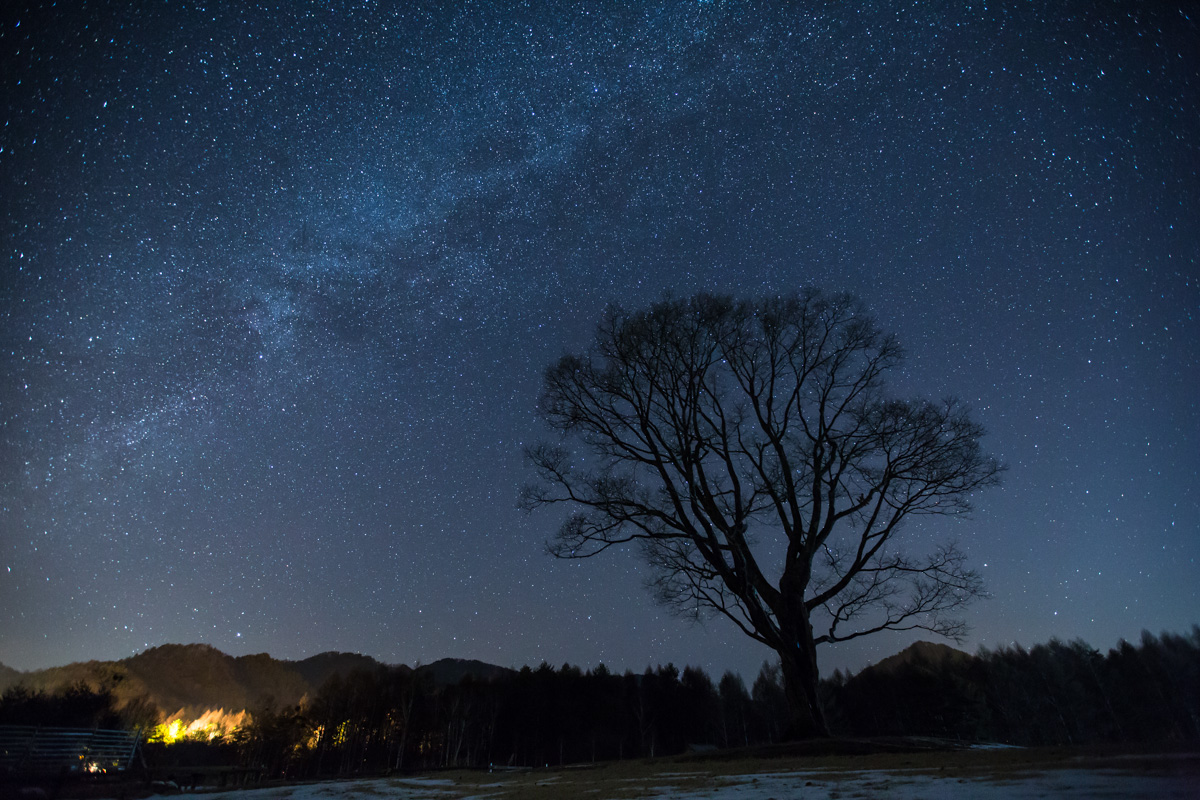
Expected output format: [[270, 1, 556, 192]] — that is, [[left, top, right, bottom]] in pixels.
[[126, 769, 1200, 800]]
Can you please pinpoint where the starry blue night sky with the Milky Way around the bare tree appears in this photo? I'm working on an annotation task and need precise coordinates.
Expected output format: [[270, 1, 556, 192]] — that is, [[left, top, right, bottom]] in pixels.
[[0, 0, 1200, 680]]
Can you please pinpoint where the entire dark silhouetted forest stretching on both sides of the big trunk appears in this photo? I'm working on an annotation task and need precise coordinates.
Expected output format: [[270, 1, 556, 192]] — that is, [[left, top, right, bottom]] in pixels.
[[0, 627, 1200, 777]]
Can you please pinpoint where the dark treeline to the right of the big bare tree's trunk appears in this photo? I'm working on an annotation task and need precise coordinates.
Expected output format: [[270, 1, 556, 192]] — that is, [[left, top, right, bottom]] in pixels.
[[822, 627, 1200, 746]]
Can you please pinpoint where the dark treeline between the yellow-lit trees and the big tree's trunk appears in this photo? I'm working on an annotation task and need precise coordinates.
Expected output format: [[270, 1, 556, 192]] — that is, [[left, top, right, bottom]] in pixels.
[[234, 664, 784, 776]]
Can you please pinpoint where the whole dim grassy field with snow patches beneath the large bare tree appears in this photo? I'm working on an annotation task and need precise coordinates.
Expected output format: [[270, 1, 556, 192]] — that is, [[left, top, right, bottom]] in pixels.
[[108, 740, 1200, 800]]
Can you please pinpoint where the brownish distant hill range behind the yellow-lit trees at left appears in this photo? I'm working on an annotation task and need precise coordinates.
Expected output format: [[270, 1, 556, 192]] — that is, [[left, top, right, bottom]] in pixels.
[[0, 644, 512, 718]]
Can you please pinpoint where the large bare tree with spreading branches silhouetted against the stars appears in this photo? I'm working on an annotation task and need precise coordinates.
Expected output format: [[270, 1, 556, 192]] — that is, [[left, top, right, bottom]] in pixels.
[[522, 290, 1002, 736]]
